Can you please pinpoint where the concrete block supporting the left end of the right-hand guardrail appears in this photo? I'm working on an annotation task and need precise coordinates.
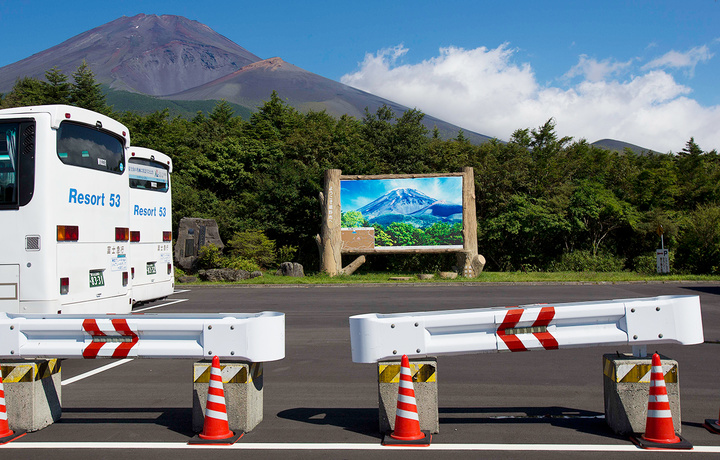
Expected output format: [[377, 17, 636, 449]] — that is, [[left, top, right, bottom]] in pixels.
[[378, 358, 440, 433]]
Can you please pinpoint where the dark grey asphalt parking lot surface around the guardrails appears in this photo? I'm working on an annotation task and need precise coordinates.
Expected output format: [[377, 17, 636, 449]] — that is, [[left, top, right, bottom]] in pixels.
[[0, 283, 720, 460]]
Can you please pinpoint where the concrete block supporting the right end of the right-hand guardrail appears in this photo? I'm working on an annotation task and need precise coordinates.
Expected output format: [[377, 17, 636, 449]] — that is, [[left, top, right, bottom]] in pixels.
[[603, 354, 682, 435]]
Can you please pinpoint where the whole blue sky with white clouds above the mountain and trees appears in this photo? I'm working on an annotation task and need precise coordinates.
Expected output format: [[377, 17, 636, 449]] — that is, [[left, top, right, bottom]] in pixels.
[[0, 0, 720, 152]]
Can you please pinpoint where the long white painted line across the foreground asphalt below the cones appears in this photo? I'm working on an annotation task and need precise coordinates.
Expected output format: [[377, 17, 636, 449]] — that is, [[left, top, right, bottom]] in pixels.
[[5, 440, 720, 453]]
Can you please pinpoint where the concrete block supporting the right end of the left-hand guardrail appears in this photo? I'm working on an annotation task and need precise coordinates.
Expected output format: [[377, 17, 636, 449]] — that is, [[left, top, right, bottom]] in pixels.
[[192, 360, 263, 433]]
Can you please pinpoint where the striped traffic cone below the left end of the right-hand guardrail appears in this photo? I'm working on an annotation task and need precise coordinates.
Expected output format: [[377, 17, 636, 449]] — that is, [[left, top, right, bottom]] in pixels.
[[382, 355, 432, 446]]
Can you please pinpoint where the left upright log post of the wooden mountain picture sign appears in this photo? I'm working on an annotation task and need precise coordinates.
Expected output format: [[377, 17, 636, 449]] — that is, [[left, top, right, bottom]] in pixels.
[[318, 169, 342, 276]]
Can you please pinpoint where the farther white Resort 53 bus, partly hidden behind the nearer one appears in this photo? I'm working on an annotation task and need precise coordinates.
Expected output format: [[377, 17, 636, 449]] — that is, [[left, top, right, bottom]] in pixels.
[[127, 147, 175, 302]]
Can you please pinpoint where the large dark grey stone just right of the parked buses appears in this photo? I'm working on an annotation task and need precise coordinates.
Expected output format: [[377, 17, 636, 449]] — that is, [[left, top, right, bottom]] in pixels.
[[175, 217, 225, 270]]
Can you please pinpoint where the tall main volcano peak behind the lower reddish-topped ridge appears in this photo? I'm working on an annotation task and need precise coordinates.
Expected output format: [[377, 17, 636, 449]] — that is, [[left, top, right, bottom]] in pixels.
[[0, 14, 260, 96]]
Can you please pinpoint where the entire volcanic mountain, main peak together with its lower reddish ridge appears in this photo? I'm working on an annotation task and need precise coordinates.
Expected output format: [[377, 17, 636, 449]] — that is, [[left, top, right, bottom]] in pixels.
[[0, 14, 490, 144]]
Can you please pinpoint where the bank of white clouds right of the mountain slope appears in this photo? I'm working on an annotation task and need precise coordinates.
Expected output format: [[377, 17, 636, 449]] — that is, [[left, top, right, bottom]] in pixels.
[[341, 43, 720, 152]]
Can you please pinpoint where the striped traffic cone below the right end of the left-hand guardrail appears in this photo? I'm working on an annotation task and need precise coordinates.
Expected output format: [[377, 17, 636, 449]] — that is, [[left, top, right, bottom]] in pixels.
[[188, 356, 243, 445]]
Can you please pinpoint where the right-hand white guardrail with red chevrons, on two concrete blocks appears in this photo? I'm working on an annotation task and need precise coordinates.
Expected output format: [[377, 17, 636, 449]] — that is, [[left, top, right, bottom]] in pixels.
[[350, 296, 704, 363]]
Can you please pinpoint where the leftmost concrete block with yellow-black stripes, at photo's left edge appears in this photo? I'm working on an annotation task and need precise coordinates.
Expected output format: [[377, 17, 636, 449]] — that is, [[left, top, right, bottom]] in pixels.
[[0, 359, 62, 431]]
